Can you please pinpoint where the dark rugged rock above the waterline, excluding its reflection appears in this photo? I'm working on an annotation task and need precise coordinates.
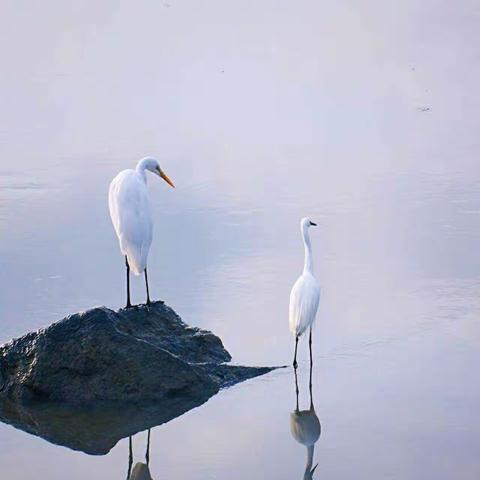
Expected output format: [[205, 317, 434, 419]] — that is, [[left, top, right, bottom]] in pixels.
[[0, 302, 278, 406]]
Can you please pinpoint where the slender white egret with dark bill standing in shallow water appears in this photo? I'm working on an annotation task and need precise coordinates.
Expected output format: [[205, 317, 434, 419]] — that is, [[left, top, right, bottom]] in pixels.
[[289, 218, 320, 368]]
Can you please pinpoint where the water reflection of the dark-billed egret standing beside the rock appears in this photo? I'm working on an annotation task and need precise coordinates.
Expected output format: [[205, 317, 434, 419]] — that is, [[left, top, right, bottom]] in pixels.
[[290, 366, 321, 480]]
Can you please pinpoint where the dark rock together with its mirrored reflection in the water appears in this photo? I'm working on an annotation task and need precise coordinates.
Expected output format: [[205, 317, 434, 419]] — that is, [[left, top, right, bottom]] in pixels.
[[0, 302, 280, 455]]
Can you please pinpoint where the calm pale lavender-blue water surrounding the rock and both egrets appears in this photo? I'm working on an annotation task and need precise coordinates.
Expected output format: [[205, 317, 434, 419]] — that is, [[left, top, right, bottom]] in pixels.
[[0, 0, 480, 480]]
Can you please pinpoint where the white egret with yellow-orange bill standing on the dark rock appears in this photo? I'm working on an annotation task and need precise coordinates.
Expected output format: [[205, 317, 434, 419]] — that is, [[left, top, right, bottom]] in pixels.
[[108, 157, 174, 308]]
